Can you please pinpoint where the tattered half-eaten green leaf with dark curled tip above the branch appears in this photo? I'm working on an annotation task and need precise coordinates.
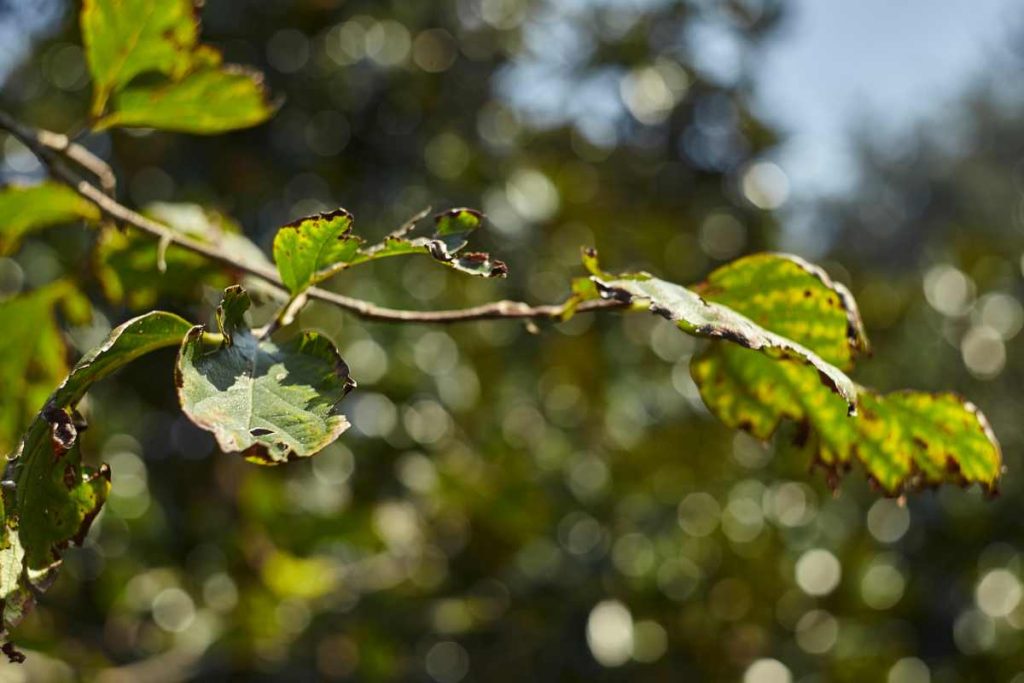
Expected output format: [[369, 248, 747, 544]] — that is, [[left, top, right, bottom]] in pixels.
[[273, 209, 508, 295]]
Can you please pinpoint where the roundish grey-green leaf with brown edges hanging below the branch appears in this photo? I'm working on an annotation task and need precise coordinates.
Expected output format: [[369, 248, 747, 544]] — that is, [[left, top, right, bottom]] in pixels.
[[175, 287, 355, 465]]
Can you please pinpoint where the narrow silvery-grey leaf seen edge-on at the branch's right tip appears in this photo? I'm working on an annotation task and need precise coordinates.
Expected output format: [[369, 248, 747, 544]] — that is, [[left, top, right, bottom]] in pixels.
[[588, 254, 857, 413]]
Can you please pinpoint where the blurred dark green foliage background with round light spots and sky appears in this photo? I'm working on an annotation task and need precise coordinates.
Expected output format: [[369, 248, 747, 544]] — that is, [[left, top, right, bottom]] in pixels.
[[0, 0, 1024, 683]]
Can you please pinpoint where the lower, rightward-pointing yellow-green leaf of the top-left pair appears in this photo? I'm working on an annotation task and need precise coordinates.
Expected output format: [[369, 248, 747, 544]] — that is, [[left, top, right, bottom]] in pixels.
[[94, 65, 276, 135]]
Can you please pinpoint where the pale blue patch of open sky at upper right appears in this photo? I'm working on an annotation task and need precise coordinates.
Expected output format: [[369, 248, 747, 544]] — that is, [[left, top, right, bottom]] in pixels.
[[757, 0, 1024, 197]]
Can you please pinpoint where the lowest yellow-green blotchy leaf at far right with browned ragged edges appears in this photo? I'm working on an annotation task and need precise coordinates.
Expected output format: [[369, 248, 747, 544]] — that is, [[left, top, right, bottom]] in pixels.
[[691, 345, 1001, 495]]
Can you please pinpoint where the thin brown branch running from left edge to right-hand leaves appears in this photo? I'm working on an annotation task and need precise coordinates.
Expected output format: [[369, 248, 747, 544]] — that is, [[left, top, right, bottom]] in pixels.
[[0, 112, 625, 323]]
